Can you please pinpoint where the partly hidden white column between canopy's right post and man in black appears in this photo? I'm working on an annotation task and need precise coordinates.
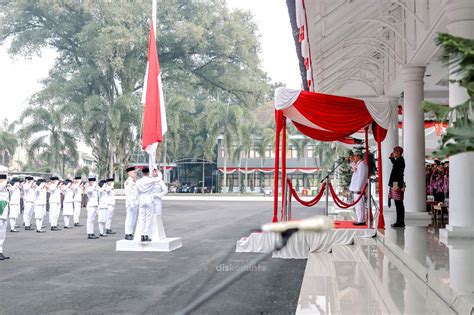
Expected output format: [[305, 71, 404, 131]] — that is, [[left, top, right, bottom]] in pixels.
[[380, 99, 398, 209]]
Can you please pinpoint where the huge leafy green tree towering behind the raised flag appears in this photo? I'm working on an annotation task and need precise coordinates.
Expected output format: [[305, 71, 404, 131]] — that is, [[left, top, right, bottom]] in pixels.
[[0, 0, 270, 176]]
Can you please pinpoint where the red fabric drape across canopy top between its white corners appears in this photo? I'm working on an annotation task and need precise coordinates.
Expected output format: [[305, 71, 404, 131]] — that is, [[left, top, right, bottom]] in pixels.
[[293, 91, 373, 133]]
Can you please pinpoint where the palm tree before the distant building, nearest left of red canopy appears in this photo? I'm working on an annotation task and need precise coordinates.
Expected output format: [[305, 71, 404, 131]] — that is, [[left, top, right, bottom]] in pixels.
[[201, 101, 245, 190]]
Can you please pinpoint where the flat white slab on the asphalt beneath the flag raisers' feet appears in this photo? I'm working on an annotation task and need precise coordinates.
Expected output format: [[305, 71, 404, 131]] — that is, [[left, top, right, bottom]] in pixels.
[[115, 237, 183, 252]]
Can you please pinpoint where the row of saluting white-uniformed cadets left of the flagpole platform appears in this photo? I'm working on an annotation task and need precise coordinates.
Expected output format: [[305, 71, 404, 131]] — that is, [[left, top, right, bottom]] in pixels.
[[2, 176, 115, 238]]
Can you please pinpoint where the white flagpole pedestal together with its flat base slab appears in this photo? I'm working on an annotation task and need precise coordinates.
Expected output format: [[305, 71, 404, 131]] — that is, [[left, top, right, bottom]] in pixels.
[[115, 214, 183, 252]]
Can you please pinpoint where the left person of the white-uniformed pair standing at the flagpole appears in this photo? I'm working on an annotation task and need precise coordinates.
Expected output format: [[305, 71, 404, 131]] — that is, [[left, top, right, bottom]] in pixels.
[[124, 166, 138, 241]]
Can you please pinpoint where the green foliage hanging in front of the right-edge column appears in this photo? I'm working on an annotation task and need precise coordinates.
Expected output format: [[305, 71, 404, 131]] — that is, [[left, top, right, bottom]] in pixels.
[[423, 33, 474, 158]]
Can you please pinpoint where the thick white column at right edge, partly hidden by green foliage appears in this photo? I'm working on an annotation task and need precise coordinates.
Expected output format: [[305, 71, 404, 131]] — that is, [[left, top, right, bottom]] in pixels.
[[440, 0, 474, 239]]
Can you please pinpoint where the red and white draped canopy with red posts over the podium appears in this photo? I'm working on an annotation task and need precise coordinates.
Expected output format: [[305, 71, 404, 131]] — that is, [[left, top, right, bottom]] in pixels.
[[273, 87, 394, 228]]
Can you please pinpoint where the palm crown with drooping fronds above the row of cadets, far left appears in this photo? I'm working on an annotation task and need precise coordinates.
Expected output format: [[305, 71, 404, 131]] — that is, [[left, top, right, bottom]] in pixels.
[[19, 105, 78, 174]]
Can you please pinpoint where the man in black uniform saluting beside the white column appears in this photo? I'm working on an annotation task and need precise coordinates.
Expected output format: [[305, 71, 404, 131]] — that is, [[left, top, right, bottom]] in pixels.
[[388, 146, 405, 228]]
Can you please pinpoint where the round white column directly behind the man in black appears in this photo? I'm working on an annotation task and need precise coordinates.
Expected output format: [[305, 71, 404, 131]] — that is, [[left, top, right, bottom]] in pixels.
[[402, 65, 430, 220]]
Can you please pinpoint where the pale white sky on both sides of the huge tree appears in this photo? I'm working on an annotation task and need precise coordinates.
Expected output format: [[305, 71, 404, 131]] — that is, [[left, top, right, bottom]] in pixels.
[[0, 0, 301, 122]]
